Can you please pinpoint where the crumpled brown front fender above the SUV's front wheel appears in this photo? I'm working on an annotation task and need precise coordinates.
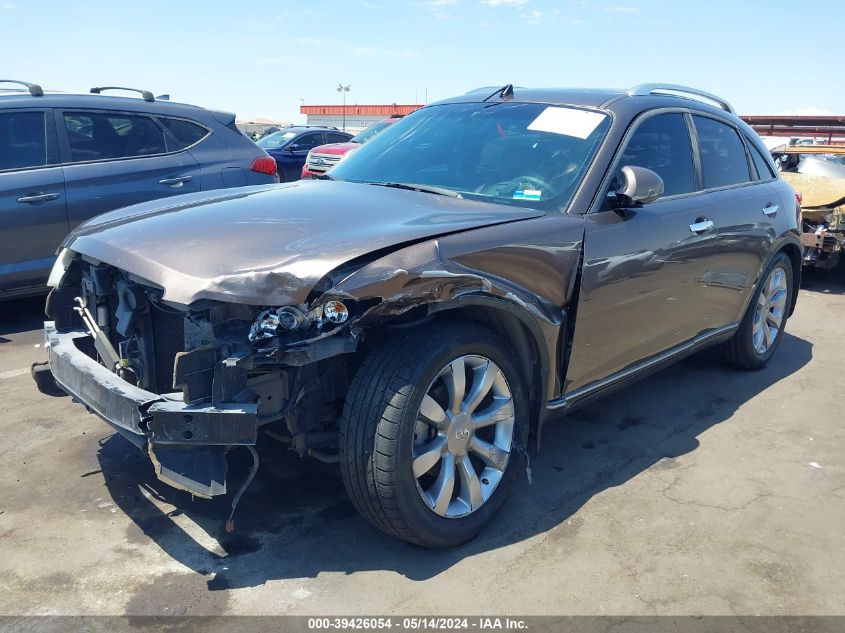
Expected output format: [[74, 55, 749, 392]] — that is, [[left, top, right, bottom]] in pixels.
[[326, 214, 584, 394]]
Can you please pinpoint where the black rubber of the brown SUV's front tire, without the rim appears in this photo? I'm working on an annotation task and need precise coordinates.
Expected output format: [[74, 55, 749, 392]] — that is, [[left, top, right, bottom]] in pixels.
[[340, 322, 529, 549]]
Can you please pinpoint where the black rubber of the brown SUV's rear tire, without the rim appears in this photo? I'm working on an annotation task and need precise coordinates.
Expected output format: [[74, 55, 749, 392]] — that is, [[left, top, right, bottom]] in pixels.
[[720, 252, 795, 370]]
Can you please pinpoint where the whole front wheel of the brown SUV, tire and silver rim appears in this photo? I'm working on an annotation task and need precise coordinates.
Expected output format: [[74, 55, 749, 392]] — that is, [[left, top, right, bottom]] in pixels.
[[340, 322, 528, 548]]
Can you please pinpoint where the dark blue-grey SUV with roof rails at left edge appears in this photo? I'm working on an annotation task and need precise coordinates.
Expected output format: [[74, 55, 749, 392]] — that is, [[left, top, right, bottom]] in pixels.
[[0, 80, 278, 300]]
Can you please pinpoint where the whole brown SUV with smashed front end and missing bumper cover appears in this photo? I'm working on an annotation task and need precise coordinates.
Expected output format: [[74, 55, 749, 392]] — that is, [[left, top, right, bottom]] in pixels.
[[36, 84, 801, 547]]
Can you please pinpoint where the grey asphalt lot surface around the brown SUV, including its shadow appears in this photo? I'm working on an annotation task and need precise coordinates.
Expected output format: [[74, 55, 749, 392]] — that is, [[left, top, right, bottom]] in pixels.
[[0, 274, 845, 615]]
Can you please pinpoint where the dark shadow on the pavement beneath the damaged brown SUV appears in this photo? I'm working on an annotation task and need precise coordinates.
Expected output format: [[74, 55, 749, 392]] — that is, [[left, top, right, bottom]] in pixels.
[[94, 334, 812, 591]]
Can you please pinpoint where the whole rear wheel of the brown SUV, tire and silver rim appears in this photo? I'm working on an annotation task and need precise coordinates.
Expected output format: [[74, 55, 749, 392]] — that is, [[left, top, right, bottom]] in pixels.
[[720, 252, 795, 369]]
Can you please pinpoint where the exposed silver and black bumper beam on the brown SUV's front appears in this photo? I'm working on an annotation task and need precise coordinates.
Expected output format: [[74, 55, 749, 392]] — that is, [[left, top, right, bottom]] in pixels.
[[44, 321, 258, 497]]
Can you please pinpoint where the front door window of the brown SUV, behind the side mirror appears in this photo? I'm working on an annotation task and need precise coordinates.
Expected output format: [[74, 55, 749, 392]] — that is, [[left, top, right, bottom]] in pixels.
[[617, 113, 695, 196]]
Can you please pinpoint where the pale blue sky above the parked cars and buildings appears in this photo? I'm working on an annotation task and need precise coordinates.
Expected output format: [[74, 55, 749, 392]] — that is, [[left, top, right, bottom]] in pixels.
[[0, 0, 845, 121]]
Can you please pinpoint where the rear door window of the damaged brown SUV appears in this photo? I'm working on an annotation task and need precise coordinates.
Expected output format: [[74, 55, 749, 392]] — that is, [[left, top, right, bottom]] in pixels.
[[692, 115, 751, 189]]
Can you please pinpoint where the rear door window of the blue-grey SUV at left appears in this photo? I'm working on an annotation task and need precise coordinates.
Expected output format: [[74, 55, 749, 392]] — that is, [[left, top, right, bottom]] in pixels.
[[64, 112, 167, 163]]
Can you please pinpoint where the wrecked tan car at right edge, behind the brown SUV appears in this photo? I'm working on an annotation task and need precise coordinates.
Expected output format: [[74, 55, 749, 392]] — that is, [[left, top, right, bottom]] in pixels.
[[772, 145, 845, 269]]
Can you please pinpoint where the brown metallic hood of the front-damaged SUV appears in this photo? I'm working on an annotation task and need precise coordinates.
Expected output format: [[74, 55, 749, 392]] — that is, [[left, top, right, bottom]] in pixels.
[[63, 180, 544, 305]]
